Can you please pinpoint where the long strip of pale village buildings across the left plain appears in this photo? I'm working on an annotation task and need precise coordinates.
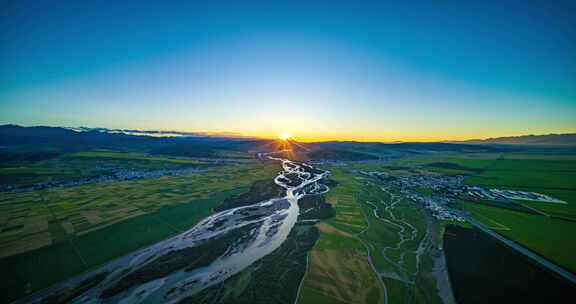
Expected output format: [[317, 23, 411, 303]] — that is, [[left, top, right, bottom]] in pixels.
[[0, 168, 202, 192]]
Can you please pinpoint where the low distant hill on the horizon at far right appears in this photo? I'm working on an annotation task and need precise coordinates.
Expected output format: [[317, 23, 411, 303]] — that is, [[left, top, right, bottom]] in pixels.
[[451, 133, 576, 146]]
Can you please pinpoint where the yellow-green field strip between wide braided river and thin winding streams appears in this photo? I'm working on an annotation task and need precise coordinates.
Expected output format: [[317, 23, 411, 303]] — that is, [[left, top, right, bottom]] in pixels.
[[299, 168, 384, 303]]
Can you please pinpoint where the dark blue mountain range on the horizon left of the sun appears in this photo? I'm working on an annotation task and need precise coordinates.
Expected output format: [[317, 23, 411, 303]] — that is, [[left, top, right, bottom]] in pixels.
[[0, 124, 271, 157]]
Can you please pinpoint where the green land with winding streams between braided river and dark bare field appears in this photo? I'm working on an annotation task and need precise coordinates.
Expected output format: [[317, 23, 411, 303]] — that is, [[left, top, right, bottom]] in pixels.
[[299, 167, 440, 303]]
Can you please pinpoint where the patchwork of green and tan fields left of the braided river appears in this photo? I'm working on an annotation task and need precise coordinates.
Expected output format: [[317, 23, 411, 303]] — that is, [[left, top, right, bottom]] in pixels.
[[0, 164, 278, 301]]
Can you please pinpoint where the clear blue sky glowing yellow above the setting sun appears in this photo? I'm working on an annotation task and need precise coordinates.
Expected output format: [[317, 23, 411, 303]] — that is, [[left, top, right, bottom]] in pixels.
[[0, 0, 576, 140]]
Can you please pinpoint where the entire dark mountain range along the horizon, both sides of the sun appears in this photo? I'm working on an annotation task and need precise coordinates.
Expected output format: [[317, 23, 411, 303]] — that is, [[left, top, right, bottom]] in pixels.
[[0, 125, 576, 161]]
